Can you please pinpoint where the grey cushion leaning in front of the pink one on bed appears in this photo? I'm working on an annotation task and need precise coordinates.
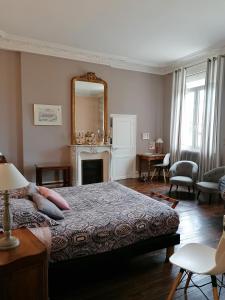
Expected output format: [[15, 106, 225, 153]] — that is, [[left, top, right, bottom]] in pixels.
[[32, 193, 64, 220]]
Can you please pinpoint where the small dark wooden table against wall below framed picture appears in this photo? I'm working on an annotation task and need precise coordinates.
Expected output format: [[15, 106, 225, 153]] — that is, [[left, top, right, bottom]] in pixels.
[[35, 164, 71, 186]]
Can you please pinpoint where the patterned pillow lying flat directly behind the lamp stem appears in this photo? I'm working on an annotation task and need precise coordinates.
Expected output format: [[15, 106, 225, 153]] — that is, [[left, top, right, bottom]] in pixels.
[[0, 199, 59, 229]]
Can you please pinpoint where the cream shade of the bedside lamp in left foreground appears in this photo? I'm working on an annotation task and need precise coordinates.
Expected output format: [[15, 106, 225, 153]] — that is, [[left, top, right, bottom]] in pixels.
[[0, 163, 29, 191]]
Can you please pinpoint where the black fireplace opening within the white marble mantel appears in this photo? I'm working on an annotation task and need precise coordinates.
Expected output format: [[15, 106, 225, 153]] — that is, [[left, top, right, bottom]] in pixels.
[[82, 159, 103, 184]]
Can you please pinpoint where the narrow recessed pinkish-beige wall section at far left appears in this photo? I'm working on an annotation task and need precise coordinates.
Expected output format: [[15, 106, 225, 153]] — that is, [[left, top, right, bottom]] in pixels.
[[0, 50, 23, 170]]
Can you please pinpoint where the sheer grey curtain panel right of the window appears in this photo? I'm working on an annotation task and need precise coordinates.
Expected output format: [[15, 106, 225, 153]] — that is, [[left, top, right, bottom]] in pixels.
[[200, 56, 225, 177]]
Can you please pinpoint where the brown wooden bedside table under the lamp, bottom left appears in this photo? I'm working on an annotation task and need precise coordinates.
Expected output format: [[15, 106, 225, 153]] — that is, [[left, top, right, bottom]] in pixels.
[[0, 228, 48, 300]]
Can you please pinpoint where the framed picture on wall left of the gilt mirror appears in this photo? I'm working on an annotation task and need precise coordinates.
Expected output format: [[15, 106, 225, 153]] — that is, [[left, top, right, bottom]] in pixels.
[[34, 104, 62, 125]]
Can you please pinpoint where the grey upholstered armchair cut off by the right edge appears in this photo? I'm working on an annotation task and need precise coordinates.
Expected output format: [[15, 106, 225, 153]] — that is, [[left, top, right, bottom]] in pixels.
[[196, 167, 225, 203]]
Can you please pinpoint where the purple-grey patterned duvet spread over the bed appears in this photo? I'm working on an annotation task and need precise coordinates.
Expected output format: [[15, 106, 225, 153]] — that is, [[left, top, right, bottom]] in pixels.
[[42, 182, 179, 262]]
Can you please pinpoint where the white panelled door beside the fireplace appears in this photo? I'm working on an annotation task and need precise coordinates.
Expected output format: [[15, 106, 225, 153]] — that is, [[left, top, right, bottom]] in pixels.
[[110, 115, 136, 180]]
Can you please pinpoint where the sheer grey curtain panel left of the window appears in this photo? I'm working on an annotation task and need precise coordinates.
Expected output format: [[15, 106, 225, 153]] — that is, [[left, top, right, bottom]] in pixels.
[[170, 68, 186, 163]]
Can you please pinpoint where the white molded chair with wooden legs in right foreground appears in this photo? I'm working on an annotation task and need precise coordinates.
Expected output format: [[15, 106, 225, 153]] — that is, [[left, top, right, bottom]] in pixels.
[[167, 216, 225, 300]]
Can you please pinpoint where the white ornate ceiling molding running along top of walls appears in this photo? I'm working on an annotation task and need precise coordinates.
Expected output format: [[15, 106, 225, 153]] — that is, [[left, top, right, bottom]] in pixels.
[[0, 30, 225, 75]]
